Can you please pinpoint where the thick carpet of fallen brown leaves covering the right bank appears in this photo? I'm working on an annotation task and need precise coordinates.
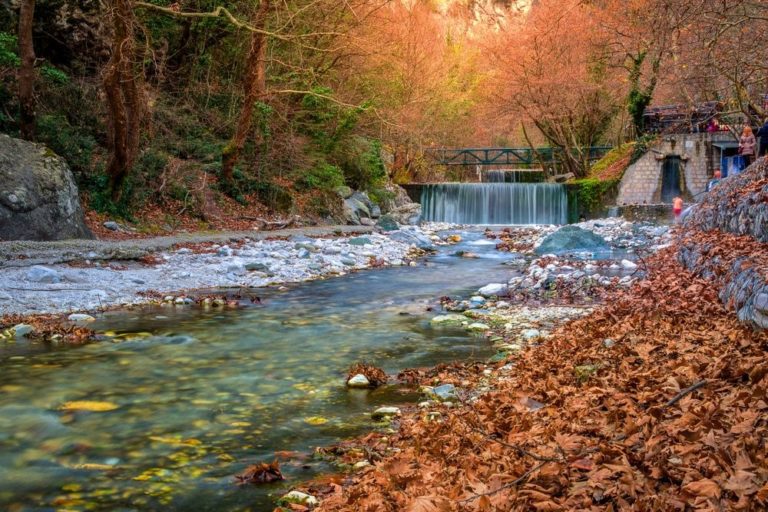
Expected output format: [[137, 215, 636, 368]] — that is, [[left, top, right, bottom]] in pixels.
[[320, 243, 768, 512]]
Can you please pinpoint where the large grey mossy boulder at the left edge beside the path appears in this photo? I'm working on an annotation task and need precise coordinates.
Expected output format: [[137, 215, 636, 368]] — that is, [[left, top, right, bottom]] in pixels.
[[0, 134, 93, 240]]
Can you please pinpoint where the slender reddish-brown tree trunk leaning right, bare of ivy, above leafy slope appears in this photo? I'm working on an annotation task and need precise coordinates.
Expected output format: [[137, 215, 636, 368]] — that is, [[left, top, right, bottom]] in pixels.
[[221, 0, 269, 184]]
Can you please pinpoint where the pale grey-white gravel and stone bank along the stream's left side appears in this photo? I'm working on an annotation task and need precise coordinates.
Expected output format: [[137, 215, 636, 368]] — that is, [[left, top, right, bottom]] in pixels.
[[0, 227, 438, 315]]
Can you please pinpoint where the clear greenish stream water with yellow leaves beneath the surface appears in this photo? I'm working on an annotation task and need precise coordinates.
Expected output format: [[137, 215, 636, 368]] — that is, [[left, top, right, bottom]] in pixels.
[[0, 233, 509, 511]]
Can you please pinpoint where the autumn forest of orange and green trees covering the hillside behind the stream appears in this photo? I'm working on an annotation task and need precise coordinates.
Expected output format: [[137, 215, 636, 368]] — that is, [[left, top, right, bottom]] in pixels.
[[0, 0, 768, 224]]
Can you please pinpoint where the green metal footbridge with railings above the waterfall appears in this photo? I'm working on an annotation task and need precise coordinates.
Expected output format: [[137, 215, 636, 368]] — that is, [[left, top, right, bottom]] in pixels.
[[424, 146, 611, 168]]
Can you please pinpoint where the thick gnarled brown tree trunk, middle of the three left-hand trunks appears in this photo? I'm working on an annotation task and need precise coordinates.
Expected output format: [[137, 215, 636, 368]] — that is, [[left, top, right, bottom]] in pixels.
[[104, 0, 144, 201]]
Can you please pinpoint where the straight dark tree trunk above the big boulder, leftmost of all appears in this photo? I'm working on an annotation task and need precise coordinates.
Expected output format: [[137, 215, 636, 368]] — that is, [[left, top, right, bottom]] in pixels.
[[19, 0, 35, 140]]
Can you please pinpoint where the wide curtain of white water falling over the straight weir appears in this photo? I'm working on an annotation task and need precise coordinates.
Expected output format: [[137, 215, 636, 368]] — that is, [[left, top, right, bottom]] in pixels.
[[421, 183, 568, 224]]
